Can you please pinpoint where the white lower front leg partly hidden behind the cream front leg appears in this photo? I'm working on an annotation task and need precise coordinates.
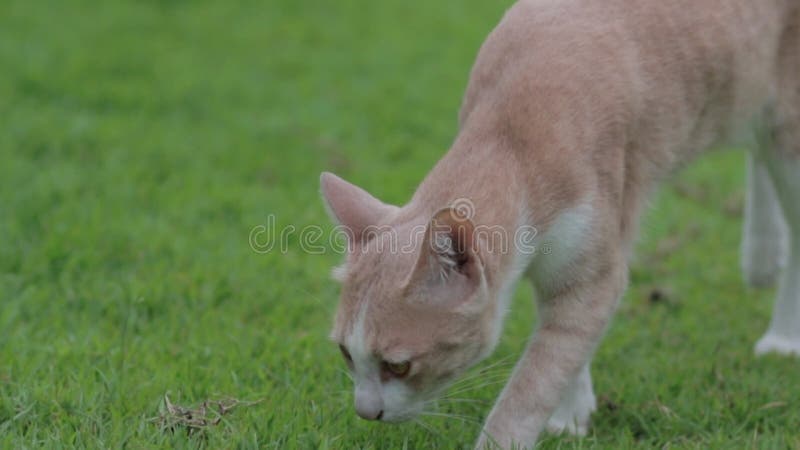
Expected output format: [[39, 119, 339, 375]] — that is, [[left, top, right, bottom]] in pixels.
[[547, 363, 597, 436]]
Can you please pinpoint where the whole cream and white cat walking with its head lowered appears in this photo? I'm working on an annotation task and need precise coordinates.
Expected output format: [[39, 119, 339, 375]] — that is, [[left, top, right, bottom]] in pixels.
[[321, 0, 800, 448]]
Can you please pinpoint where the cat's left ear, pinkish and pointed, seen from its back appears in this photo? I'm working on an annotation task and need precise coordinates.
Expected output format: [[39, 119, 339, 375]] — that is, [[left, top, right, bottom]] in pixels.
[[319, 172, 397, 241]]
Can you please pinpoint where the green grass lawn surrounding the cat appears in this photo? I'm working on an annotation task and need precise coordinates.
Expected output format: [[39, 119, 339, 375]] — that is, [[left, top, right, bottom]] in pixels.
[[0, 0, 800, 449]]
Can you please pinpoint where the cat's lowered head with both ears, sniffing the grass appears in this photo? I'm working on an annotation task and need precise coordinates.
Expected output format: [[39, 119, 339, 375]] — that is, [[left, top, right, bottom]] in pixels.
[[321, 173, 501, 422]]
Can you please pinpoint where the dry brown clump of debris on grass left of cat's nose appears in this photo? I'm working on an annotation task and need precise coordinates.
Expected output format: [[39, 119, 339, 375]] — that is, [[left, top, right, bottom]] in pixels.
[[150, 393, 263, 435]]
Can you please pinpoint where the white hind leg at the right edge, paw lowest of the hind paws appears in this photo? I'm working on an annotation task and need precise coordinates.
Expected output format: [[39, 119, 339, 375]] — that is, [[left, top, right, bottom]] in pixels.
[[756, 154, 800, 356]]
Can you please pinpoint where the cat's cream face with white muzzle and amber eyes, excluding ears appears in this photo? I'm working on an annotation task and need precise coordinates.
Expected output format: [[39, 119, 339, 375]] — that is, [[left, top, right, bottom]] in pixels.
[[332, 241, 492, 422]]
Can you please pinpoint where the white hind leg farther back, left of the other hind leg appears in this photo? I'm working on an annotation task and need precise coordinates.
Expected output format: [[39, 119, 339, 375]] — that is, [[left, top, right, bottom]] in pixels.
[[741, 154, 788, 287]]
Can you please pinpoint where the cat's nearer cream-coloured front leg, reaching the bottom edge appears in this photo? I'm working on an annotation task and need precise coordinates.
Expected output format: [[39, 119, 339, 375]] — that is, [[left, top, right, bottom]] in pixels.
[[476, 258, 627, 450]]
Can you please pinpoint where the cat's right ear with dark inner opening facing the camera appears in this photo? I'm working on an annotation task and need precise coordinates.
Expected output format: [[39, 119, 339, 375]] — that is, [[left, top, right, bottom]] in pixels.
[[409, 208, 484, 299]]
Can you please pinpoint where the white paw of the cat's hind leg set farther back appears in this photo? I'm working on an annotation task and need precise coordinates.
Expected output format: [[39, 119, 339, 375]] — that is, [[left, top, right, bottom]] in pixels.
[[742, 237, 786, 287]]
